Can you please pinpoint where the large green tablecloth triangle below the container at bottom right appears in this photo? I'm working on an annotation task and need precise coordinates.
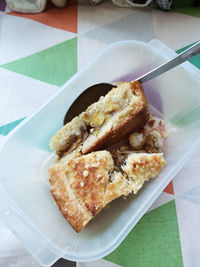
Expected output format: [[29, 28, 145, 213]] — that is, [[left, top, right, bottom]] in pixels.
[[105, 200, 183, 267]]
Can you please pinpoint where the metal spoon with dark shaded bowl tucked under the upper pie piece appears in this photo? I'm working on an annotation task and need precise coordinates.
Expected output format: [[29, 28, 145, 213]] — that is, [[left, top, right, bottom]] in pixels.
[[64, 41, 200, 124]]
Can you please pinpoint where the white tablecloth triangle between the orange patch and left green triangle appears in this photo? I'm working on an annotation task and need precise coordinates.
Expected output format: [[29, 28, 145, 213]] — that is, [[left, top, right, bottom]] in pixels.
[[0, 13, 76, 64]]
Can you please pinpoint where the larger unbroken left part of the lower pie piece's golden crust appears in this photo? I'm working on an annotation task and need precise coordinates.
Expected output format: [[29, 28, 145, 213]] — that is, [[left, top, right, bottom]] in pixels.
[[49, 151, 114, 232]]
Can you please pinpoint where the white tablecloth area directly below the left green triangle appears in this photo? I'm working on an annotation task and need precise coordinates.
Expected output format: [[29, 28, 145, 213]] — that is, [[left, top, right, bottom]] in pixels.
[[0, 68, 59, 126]]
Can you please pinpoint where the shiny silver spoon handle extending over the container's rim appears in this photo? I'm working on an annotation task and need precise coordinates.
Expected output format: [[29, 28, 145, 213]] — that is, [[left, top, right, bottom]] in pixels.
[[136, 41, 200, 83]]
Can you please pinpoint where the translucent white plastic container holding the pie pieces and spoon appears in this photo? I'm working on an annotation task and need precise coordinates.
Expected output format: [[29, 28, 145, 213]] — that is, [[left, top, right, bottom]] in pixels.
[[0, 40, 200, 266]]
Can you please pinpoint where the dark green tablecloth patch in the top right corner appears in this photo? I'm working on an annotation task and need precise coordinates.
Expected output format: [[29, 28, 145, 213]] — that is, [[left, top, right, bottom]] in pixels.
[[170, 0, 200, 18]]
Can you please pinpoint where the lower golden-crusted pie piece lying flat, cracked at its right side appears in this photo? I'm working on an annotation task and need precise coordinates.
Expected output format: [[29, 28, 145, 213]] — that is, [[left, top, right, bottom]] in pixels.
[[49, 151, 166, 232]]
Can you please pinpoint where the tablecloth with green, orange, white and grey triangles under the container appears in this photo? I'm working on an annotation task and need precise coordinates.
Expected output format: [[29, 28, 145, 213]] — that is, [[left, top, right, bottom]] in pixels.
[[0, 0, 200, 267]]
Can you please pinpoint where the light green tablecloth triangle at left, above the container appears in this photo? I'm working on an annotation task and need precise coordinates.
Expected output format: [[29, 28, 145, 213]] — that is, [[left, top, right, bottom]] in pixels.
[[0, 38, 77, 86]]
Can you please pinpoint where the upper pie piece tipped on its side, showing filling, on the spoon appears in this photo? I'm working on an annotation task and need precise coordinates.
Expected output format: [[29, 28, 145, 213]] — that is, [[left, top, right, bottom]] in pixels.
[[50, 82, 149, 158]]
